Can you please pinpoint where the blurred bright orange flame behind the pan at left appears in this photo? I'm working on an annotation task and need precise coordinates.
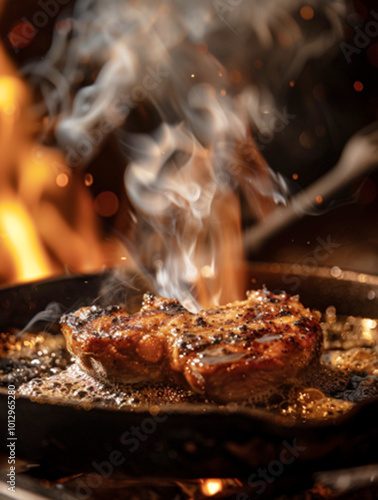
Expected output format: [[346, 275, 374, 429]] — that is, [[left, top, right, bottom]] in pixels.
[[0, 46, 125, 283]]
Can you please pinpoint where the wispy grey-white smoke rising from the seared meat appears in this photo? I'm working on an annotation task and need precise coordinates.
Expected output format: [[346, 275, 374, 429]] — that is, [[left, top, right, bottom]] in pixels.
[[24, 0, 346, 310]]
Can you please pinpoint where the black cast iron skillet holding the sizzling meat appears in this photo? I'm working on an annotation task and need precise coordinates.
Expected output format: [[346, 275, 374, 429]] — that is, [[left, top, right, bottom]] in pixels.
[[0, 264, 378, 479]]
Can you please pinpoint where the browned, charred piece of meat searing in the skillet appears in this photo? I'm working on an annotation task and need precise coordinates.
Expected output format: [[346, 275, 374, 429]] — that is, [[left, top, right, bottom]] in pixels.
[[61, 290, 322, 402]]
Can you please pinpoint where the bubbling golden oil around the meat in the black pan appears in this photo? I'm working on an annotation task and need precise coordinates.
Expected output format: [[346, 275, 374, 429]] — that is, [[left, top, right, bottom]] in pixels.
[[0, 307, 378, 421]]
